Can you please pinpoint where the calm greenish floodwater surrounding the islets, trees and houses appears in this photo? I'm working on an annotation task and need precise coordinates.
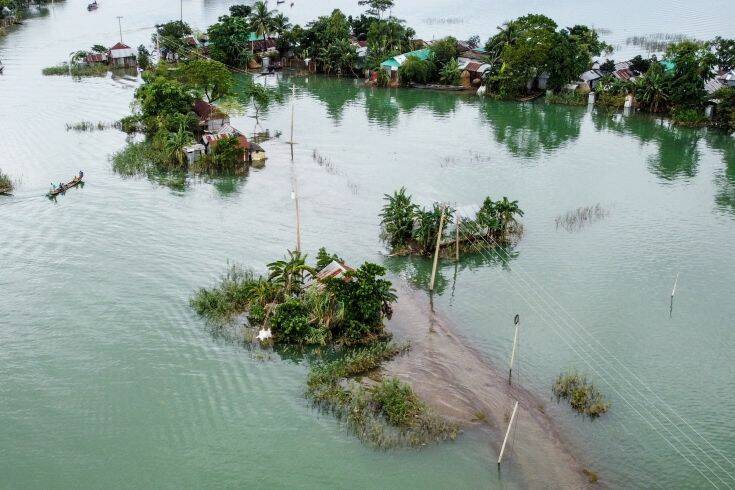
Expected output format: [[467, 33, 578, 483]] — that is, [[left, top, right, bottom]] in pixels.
[[0, 0, 735, 488]]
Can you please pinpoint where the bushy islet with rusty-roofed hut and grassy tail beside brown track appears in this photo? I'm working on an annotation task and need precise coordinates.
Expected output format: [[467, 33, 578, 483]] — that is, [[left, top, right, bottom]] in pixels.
[[191, 248, 458, 447]]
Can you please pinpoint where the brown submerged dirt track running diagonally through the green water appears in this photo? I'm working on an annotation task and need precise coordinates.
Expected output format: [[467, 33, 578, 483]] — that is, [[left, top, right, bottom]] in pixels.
[[383, 280, 590, 488]]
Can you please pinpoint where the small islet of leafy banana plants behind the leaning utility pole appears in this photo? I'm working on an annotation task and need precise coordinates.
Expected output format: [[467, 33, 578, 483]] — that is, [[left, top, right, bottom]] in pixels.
[[380, 188, 523, 255]]
